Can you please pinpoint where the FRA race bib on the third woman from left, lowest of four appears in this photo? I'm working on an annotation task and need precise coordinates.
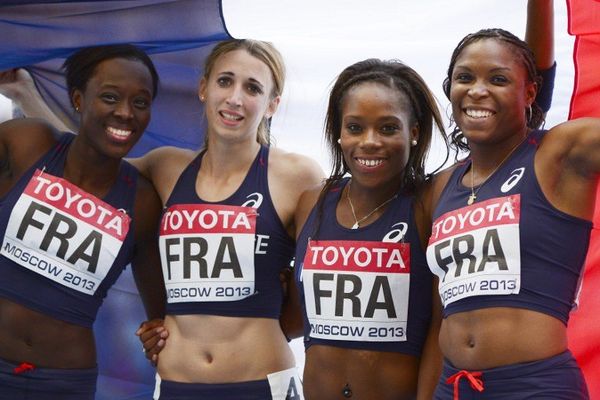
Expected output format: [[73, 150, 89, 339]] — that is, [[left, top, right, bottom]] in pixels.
[[302, 241, 410, 342]]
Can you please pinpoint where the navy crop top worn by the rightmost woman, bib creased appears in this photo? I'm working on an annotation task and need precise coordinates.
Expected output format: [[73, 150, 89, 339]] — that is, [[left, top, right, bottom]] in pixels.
[[427, 131, 592, 324]]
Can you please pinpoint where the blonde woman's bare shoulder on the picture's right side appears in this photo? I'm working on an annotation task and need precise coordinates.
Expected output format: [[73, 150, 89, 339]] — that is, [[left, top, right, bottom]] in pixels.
[[269, 148, 324, 194]]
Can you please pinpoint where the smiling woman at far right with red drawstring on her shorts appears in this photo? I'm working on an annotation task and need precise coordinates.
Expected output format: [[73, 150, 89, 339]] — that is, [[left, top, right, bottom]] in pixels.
[[427, 29, 600, 399]]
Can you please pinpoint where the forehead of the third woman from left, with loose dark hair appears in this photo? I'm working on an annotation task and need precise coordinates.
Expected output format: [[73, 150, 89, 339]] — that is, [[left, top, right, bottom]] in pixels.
[[342, 82, 411, 114]]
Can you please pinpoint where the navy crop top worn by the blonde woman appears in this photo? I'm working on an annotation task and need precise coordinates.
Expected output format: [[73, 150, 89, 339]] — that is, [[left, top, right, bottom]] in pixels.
[[159, 146, 294, 319]]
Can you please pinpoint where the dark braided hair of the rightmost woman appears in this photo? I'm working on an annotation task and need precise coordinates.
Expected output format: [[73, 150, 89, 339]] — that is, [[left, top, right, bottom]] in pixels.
[[443, 28, 544, 151]]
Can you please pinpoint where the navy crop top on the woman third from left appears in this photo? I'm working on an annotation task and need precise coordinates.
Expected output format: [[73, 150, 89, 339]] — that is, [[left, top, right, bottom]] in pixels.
[[295, 179, 433, 356]]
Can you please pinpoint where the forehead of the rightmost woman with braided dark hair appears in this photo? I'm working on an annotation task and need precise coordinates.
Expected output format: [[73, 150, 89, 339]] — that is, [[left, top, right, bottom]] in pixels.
[[455, 38, 524, 69]]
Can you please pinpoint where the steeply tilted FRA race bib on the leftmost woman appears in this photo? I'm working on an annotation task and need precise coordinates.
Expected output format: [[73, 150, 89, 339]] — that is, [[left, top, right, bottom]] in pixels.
[[0, 170, 131, 295]]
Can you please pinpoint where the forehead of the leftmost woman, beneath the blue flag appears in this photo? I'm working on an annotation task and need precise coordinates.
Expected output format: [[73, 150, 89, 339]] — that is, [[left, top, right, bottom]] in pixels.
[[87, 58, 153, 94]]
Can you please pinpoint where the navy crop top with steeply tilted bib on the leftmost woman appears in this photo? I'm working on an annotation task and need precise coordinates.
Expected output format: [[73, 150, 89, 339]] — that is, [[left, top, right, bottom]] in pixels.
[[0, 133, 137, 328]]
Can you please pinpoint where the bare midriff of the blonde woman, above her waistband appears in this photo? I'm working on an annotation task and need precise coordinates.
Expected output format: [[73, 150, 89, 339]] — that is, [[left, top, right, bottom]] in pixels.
[[158, 315, 295, 383]]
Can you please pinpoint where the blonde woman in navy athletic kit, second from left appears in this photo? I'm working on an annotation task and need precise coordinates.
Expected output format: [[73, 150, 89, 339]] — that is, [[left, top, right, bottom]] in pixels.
[[136, 39, 322, 400]]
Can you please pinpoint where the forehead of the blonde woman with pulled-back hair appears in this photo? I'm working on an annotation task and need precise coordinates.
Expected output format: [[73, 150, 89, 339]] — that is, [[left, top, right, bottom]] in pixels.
[[212, 49, 272, 85]]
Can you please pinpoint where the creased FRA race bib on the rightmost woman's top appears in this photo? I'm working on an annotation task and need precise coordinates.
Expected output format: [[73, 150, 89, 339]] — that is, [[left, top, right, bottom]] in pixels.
[[427, 194, 521, 306]]
